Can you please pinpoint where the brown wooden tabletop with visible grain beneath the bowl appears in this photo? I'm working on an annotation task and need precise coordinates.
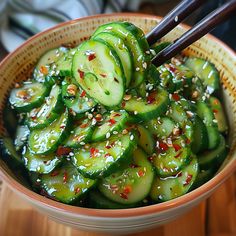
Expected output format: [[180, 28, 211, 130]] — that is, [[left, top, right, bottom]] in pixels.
[[0, 173, 236, 236]]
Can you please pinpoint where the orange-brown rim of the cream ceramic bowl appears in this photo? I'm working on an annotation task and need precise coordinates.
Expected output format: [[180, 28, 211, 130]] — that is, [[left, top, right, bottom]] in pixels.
[[0, 13, 236, 218]]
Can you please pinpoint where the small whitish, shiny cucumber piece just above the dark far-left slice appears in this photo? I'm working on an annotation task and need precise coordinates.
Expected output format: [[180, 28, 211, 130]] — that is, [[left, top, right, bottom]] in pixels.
[[14, 125, 30, 151]]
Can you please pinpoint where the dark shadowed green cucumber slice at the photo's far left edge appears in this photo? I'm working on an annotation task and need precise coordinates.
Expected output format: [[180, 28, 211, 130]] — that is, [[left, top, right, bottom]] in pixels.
[[0, 137, 24, 168]]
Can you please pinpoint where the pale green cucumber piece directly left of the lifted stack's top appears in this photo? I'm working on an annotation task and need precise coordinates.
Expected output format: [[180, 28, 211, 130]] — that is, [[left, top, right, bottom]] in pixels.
[[55, 48, 77, 76]]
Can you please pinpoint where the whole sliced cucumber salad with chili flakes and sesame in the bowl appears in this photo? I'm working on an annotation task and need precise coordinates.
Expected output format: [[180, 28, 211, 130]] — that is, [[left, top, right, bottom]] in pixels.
[[1, 22, 228, 209]]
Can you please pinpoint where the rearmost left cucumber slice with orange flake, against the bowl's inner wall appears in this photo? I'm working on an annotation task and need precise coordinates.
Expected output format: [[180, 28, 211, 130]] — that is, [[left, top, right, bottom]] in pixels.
[[33, 47, 68, 83]]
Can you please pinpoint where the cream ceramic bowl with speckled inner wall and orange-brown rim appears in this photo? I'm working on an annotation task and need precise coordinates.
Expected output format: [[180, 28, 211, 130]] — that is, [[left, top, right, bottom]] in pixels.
[[0, 13, 236, 234]]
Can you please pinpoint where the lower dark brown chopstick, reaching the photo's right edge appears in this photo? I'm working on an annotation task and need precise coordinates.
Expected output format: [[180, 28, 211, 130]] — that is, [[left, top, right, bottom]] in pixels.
[[152, 0, 236, 66]]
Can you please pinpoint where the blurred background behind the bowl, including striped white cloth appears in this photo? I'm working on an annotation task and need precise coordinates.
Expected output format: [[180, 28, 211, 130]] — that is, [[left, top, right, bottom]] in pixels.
[[0, 0, 236, 55]]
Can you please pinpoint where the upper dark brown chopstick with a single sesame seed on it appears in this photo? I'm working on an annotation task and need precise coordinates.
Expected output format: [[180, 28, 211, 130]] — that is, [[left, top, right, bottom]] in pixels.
[[146, 0, 206, 45]]
